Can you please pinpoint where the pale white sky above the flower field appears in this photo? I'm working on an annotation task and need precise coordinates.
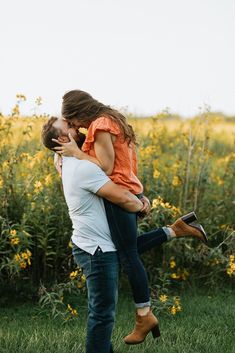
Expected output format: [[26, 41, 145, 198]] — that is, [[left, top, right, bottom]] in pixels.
[[0, 0, 235, 116]]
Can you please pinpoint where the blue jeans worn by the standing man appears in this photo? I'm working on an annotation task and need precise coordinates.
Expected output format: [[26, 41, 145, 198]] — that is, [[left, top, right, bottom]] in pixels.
[[73, 245, 118, 353]]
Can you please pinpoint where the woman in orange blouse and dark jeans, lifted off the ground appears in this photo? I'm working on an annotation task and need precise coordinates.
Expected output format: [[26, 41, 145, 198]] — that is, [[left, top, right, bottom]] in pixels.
[[52, 90, 206, 344]]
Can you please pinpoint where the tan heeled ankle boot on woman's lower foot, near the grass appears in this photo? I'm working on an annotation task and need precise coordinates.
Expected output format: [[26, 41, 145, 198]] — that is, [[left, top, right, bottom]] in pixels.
[[124, 310, 160, 344]]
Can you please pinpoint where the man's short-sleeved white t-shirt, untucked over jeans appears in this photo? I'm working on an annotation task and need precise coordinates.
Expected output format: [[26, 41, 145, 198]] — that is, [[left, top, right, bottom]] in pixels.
[[62, 157, 116, 255]]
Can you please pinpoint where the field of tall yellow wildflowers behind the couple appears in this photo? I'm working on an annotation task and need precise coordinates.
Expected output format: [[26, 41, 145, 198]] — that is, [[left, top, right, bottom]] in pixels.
[[0, 107, 235, 311]]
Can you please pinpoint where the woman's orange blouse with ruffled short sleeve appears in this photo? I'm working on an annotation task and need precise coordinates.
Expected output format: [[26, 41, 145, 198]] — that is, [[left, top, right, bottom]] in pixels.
[[82, 116, 143, 195]]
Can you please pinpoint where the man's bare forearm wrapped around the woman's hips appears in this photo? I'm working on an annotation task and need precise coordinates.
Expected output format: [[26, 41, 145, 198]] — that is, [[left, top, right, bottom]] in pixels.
[[96, 180, 143, 212]]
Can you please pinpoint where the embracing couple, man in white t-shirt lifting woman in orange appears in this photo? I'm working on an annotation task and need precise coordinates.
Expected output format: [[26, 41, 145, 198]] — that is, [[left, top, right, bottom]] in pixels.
[[42, 90, 207, 353]]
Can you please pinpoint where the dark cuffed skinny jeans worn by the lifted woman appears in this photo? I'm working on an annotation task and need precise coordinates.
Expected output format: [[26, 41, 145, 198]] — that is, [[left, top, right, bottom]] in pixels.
[[104, 199, 167, 308]]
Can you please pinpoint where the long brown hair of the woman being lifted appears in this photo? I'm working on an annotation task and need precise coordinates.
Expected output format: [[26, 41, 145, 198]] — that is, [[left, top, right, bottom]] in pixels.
[[62, 90, 136, 144]]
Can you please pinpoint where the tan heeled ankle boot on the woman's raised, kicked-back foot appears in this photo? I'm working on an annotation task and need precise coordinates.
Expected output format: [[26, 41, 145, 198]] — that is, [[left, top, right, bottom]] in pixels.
[[170, 218, 207, 243]]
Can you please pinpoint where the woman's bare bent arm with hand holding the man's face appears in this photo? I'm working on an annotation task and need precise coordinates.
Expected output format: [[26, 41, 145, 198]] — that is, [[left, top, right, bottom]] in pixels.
[[54, 131, 115, 175]]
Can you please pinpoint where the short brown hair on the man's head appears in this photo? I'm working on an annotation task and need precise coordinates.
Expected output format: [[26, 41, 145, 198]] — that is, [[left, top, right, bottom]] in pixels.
[[41, 116, 61, 150]]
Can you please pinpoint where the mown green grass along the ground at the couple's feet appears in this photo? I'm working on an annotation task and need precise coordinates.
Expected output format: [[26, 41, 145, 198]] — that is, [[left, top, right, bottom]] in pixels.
[[0, 290, 235, 353]]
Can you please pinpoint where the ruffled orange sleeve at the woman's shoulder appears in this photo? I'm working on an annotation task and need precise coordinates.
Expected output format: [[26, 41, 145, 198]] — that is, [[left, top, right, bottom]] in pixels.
[[82, 116, 120, 152]]
